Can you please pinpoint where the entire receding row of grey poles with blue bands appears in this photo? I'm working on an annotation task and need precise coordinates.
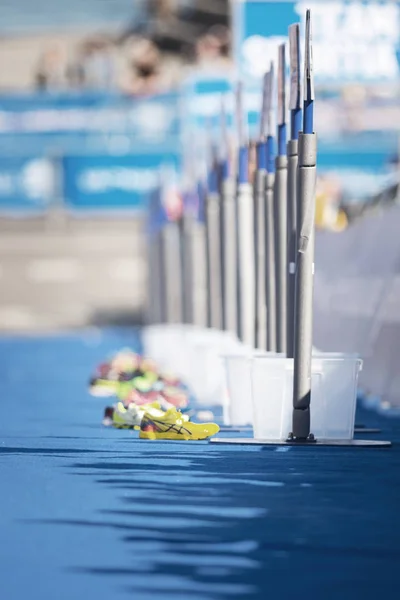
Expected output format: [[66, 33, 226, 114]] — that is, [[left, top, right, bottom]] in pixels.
[[150, 11, 316, 441]]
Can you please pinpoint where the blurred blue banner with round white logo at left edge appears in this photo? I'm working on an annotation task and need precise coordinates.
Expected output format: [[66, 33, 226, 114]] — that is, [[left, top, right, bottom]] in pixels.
[[0, 156, 55, 216]]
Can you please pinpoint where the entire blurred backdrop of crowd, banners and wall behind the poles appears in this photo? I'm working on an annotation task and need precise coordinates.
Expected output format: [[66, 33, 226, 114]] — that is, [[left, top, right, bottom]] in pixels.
[[0, 0, 400, 338]]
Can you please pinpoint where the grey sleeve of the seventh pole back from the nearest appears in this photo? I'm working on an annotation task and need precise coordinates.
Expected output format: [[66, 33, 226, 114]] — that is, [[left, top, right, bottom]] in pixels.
[[221, 178, 238, 335]]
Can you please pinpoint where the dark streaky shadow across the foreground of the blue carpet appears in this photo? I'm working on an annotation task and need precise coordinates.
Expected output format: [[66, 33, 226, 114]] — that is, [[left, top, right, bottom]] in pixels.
[[28, 415, 400, 600]]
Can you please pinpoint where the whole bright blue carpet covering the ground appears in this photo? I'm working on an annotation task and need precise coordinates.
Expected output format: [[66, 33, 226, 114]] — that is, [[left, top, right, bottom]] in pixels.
[[0, 330, 400, 600]]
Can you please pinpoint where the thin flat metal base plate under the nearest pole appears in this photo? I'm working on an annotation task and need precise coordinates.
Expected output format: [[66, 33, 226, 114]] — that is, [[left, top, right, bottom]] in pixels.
[[210, 438, 392, 448]]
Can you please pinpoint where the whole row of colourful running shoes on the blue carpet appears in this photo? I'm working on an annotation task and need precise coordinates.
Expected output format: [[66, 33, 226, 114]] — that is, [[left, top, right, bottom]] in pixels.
[[89, 349, 219, 440]]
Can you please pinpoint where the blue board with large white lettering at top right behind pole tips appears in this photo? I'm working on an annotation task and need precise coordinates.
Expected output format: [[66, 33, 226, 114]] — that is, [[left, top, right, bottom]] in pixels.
[[232, 0, 400, 86]]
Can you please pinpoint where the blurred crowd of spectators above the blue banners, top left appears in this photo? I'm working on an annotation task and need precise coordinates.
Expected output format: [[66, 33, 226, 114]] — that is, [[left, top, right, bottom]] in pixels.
[[34, 0, 231, 94]]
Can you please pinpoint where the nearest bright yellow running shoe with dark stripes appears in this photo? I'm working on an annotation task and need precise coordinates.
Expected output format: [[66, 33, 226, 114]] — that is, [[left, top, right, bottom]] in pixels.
[[139, 408, 219, 440]]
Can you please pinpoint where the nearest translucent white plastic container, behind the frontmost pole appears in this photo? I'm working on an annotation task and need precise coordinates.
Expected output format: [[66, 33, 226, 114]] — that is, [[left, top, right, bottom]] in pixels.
[[251, 353, 362, 440]]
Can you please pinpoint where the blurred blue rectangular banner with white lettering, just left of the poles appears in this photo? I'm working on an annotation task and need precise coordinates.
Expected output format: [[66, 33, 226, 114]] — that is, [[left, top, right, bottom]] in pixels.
[[62, 152, 180, 211]]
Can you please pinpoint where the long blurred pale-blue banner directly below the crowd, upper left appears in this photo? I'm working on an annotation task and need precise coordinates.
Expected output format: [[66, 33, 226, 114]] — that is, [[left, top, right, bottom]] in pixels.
[[0, 92, 180, 142]]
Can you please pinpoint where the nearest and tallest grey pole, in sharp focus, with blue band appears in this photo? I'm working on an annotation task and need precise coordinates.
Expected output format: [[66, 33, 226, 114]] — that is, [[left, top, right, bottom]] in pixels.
[[291, 10, 317, 440]]
